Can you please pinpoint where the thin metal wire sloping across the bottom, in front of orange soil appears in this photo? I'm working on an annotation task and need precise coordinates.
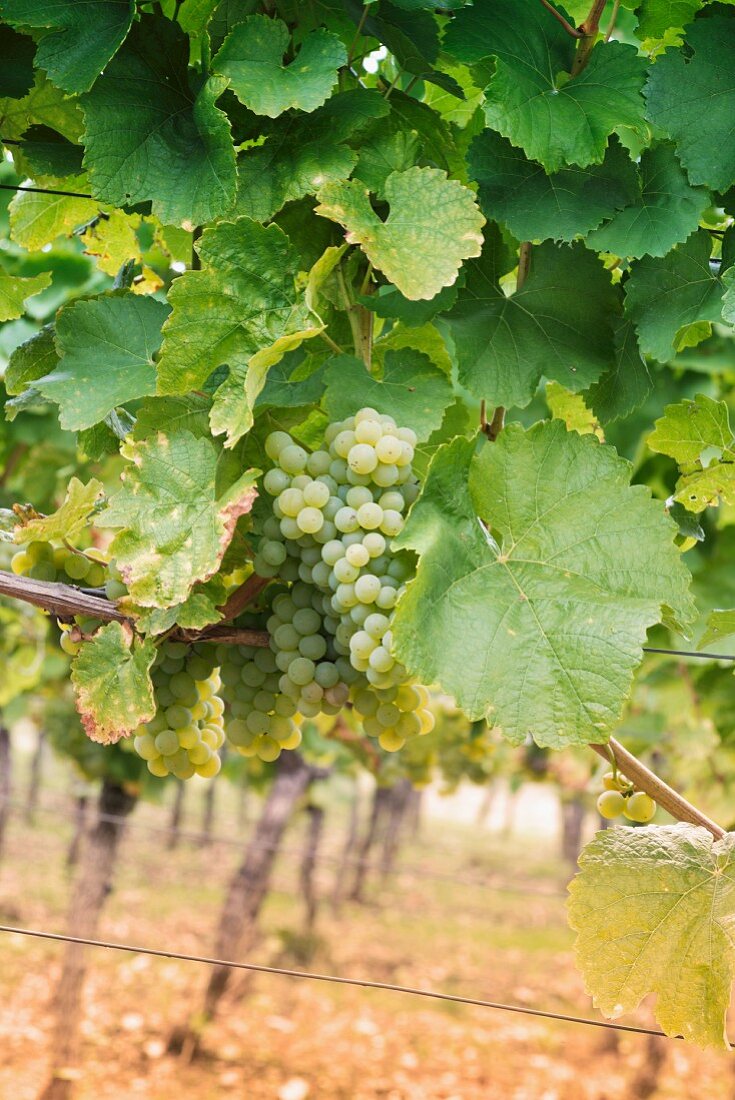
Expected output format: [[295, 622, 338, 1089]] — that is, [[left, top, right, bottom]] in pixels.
[[0, 924, 680, 1038]]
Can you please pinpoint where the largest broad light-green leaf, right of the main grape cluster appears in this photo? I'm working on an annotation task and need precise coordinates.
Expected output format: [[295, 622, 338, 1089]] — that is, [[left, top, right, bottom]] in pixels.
[[394, 420, 693, 748]]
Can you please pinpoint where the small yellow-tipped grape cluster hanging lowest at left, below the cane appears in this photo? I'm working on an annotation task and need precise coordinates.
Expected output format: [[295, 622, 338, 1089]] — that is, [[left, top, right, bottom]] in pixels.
[[133, 641, 224, 779]]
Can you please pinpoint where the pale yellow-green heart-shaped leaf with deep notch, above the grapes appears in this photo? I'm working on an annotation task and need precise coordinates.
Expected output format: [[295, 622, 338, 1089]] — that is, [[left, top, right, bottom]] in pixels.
[[316, 167, 485, 299]]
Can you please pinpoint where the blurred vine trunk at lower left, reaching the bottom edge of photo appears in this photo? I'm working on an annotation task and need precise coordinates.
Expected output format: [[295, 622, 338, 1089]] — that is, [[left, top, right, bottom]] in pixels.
[[40, 780, 138, 1100]]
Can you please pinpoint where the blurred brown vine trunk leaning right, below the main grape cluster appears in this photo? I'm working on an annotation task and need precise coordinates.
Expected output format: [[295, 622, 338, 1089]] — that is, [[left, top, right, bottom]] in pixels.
[[168, 752, 314, 1059]]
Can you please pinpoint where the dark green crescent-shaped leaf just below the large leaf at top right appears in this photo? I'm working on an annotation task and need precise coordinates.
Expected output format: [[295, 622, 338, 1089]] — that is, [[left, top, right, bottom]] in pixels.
[[468, 130, 637, 244]]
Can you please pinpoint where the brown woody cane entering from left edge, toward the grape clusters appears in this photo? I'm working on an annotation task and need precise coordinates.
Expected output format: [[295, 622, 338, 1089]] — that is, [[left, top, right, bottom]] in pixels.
[[0, 570, 270, 649]]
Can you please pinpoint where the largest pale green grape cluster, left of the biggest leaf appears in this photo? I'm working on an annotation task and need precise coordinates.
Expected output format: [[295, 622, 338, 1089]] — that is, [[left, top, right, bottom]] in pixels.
[[243, 408, 434, 750]]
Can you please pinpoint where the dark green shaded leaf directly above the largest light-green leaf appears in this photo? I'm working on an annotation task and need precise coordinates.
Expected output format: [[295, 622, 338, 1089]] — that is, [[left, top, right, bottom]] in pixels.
[[445, 242, 619, 406]]
